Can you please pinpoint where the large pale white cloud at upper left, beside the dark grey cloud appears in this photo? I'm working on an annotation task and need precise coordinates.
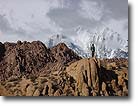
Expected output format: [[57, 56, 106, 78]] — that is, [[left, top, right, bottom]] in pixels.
[[0, 0, 62, 39]]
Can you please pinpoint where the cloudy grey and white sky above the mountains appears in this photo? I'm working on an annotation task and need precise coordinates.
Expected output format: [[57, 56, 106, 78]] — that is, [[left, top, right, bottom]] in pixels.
[[0, 0, 128, 42]]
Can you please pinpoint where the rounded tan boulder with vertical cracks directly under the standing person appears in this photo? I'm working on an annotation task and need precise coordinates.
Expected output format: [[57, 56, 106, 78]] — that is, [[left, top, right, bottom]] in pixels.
[[66, 58, 99, 93]]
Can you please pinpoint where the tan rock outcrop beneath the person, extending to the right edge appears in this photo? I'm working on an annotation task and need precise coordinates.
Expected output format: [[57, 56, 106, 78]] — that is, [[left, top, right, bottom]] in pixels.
[[66, 58, 128, 96]]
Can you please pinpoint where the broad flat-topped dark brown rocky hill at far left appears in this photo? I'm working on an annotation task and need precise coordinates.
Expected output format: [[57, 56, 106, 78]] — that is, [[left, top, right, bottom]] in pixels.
[[0, 41, 54, 80]]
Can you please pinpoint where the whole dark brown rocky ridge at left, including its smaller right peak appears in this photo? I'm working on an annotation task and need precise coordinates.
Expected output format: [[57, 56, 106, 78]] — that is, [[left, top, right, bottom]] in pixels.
[[0, 41, 81, 80]]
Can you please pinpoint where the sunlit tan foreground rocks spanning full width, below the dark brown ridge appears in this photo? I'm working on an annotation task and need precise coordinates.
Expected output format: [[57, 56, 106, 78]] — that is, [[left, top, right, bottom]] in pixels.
[[0, 58, 128, 96]]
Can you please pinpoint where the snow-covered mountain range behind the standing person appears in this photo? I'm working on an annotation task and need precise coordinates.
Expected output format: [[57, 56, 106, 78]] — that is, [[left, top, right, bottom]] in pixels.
[[46, 27, 128, 58]]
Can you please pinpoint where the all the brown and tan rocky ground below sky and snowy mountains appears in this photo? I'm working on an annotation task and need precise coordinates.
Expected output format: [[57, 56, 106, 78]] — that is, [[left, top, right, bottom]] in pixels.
[[0, 41, 128, 96]]
